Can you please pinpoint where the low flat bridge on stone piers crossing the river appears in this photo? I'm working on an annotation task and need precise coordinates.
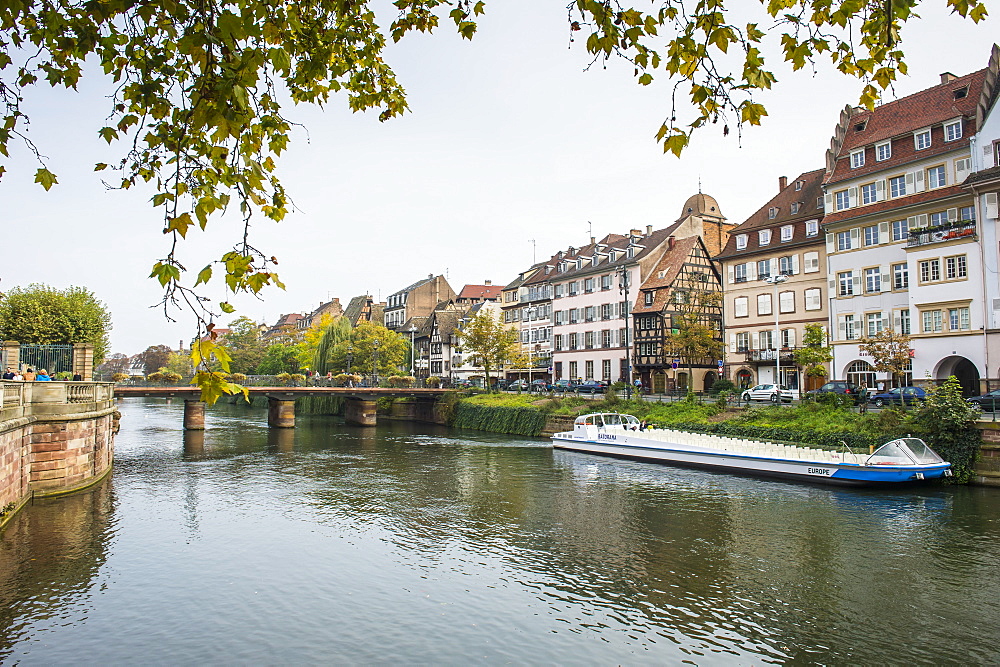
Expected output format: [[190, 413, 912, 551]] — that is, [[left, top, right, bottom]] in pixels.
[[115, 385, 447, 430]]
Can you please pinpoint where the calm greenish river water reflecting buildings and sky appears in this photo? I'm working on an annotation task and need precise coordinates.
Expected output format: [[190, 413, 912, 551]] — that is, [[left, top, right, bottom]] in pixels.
[[0, 399, 1000, 665]]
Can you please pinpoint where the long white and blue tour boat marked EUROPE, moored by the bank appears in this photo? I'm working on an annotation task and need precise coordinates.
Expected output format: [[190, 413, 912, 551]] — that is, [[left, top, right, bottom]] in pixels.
[[552, 412, 952, 485]]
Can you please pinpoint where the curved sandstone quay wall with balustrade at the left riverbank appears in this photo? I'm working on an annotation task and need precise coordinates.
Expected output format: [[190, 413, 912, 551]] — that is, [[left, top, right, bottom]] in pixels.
[[0, 380, 119, 526]]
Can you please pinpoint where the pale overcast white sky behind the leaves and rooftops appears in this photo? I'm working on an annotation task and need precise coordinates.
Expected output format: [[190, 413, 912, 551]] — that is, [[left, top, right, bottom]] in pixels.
[[0, 0, 998, 354]]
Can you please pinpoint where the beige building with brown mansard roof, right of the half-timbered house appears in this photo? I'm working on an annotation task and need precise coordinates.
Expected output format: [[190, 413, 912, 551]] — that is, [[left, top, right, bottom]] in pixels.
[[716, 169, 828, 391]]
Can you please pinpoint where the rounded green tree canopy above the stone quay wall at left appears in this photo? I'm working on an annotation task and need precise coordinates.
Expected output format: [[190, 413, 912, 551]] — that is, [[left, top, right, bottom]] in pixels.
[[0, 284, 111, 365]]
